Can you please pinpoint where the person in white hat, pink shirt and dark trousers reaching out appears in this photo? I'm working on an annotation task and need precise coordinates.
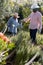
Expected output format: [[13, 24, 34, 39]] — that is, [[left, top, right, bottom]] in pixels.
[[24, 4, 42, 43]]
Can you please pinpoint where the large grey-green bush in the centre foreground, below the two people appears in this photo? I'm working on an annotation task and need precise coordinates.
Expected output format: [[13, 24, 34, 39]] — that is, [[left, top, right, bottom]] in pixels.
[[12, 31, 40, 65]]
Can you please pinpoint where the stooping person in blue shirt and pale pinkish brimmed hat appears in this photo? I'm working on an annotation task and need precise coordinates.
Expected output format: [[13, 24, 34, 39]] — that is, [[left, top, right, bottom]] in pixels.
[[7, 12, 19, 34]]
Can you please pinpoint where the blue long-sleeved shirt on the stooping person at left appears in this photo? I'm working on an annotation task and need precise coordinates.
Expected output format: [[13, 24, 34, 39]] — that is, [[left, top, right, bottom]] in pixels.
[[7, 17, 19, 33]]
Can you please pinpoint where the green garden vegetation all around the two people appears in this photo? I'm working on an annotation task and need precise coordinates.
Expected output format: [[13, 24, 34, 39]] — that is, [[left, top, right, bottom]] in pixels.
[[0, 0, 43, 65]]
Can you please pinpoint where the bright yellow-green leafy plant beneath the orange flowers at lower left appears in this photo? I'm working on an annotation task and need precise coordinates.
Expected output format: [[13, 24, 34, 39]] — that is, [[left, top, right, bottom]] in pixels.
[[0, 38, 15, 65]]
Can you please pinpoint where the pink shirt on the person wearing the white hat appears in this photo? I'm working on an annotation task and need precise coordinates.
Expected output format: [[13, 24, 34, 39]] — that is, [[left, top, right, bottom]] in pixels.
[[29, 11, 42, 29]]
